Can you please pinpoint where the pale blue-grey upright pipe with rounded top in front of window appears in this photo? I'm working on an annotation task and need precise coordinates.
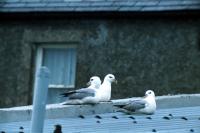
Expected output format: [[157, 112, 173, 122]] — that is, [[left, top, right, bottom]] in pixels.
[[31, 67, 50, 133]]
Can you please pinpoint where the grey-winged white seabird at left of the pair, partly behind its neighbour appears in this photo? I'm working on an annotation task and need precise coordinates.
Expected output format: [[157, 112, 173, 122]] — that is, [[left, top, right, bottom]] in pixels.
[[61, 76, 101, 104]]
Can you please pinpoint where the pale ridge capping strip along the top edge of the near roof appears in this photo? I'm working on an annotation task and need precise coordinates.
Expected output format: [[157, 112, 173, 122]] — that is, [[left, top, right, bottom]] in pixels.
[[0, 94, 200, 123]]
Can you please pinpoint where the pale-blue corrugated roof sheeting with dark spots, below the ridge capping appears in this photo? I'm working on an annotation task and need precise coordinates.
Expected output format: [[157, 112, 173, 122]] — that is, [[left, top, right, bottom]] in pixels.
[[0, 106, 200, 133]]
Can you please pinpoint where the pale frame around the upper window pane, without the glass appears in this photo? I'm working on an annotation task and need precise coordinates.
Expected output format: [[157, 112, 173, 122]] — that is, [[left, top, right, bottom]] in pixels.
[[35, 43, 77, 89]]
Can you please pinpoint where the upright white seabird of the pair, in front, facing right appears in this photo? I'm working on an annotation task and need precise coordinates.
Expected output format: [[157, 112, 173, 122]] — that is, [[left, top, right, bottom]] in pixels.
[[98, 74, 117, 102]]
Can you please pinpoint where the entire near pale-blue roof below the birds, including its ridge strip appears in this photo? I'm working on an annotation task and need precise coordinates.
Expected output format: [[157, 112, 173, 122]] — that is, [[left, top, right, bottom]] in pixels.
[[0, 94, 200, 133]]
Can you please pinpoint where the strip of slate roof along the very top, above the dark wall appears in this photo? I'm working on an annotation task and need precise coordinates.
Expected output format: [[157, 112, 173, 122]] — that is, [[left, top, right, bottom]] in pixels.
[[0, 0, 200, 13]]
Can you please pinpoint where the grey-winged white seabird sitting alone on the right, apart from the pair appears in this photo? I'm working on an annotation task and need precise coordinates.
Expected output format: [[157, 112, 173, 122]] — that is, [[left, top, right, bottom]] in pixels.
[[114, 90, 156, 114]]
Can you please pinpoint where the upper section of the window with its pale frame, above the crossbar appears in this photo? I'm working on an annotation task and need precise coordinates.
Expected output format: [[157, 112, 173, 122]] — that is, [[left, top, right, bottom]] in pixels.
[[36, 45, 76, 88]]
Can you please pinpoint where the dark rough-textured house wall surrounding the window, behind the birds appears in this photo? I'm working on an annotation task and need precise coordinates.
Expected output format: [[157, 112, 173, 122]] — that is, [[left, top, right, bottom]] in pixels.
[[0, 17, 200, 107]]
